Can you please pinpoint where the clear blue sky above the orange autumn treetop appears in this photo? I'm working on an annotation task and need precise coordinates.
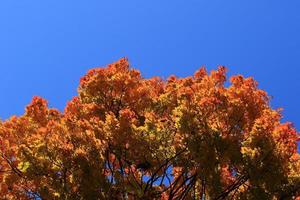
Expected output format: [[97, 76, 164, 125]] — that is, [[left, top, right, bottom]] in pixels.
[[0, 0, 300, 133]]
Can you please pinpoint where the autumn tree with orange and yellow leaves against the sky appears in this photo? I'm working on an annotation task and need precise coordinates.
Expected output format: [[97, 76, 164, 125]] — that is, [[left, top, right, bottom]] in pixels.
[[0, 59, 300, 200]]
